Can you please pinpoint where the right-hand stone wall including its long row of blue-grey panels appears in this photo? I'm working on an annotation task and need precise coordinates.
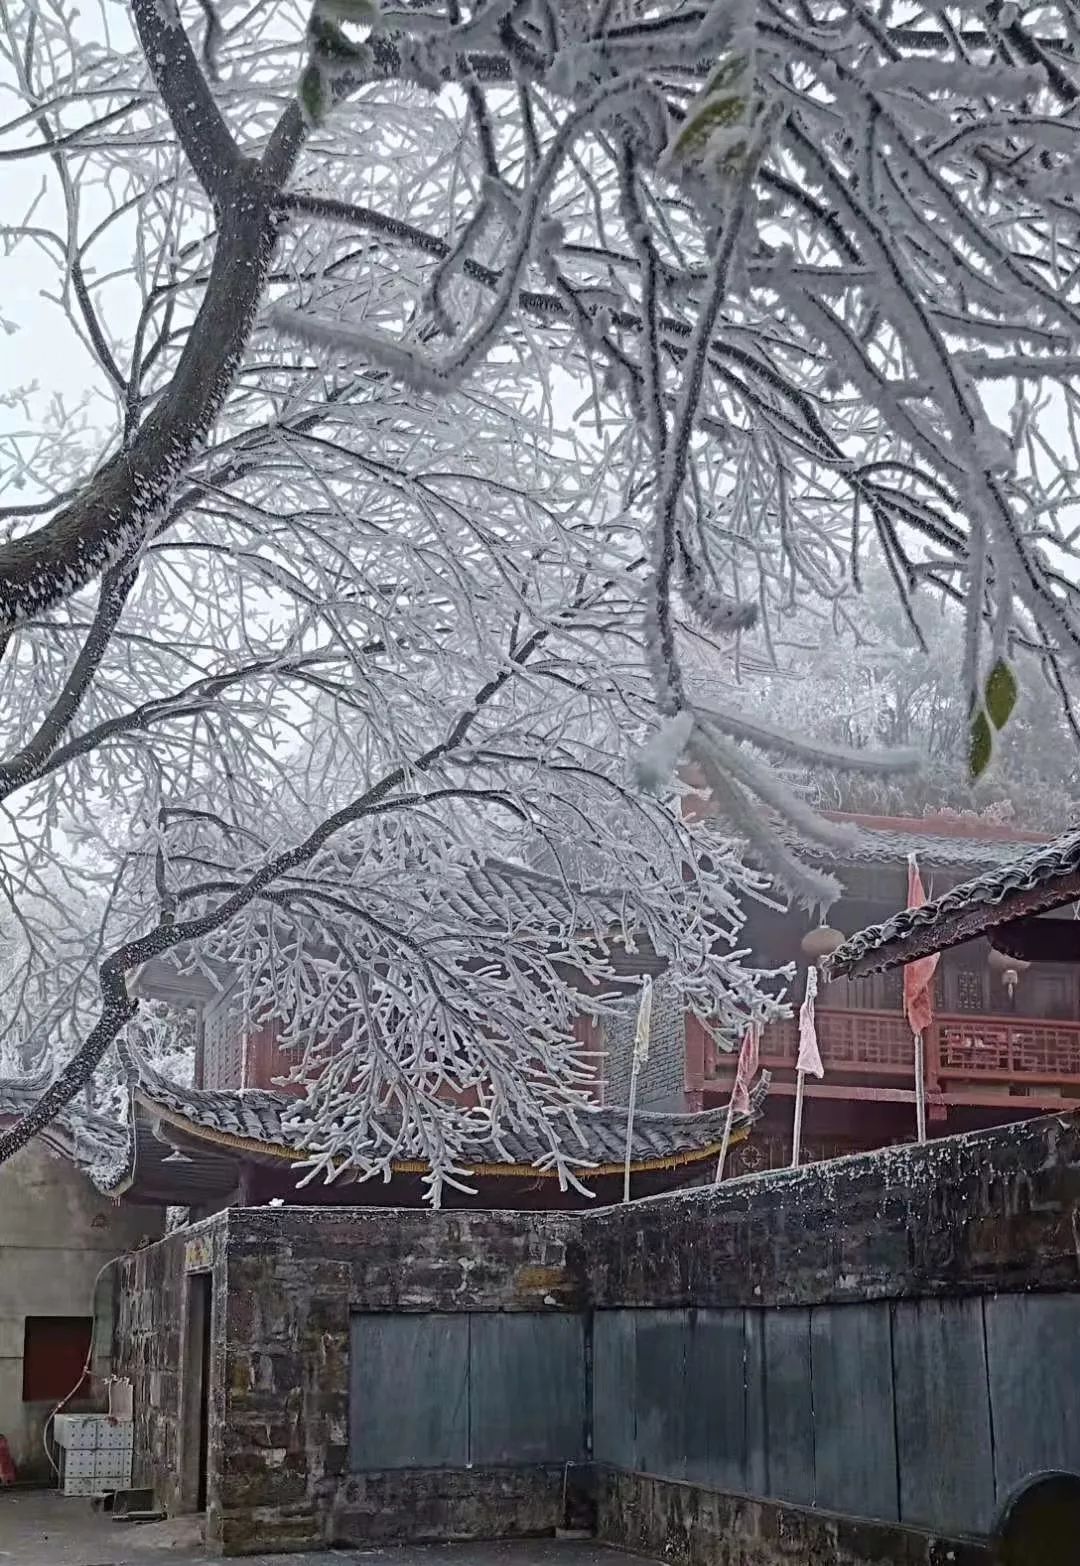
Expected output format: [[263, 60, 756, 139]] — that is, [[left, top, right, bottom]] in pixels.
[[582, 1117, 1080, 1566]]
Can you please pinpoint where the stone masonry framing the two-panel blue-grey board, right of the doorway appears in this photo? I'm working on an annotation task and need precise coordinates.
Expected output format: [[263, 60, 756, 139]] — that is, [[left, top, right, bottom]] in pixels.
[[210, 1207, 582, 1550]]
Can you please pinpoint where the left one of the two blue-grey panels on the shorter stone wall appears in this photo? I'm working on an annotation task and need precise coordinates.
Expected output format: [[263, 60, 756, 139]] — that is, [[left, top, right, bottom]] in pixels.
[[349, 1314, 468, 1472]]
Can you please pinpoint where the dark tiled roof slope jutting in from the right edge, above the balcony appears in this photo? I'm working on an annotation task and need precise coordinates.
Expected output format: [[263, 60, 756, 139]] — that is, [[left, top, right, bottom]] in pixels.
[[828, 832, 1080, 977]]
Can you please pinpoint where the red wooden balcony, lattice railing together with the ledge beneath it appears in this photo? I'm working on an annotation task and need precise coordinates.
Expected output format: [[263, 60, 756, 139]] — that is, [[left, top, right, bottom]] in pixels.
[[704, 1009, 1080, 1109]]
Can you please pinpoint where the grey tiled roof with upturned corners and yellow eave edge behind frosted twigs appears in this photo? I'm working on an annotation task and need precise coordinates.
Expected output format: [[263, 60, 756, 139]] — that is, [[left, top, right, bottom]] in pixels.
[[136, 1066, 769, 1175]]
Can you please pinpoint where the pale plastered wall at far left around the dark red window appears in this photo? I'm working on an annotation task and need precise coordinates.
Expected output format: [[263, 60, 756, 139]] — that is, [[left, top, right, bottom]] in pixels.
[[0, 1142, 161, 1480]]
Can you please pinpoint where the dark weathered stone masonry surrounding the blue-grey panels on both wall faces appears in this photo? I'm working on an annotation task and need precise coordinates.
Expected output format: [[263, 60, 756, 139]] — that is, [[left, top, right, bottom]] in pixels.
[[111, 1117, 1080, 1566]]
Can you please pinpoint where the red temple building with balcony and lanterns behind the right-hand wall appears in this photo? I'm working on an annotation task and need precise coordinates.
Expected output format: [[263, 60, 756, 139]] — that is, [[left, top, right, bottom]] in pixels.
[[606, 813, 1080, 1175]]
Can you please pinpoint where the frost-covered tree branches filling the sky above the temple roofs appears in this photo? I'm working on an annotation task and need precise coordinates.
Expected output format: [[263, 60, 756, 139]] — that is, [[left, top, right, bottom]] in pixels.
[[0, 0, 1080, 1187]]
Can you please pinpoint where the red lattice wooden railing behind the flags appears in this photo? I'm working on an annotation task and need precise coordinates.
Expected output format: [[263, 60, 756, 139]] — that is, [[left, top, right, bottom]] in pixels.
[[706, 1009, 1080, 1084]]
